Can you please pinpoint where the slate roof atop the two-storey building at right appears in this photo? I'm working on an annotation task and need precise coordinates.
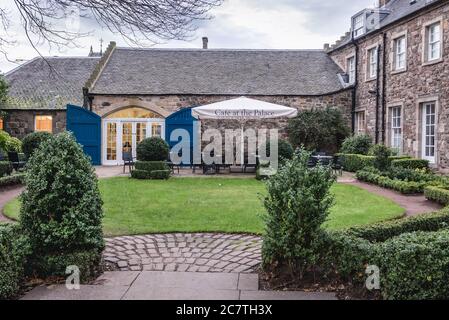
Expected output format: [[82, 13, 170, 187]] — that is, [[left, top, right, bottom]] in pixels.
[[331, 0, 447, 51]]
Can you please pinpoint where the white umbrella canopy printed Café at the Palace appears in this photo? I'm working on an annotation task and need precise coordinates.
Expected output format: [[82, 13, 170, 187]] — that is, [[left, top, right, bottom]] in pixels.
[[192, 97, 298, 121]]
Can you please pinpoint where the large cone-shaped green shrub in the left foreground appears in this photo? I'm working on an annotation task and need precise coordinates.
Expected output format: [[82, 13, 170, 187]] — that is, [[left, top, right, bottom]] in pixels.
[[20, 132, 104, 257]]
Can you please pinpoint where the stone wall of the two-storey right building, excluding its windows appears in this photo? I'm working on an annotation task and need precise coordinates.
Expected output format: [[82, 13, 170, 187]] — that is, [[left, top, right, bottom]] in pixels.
[[330, 3, 449, 170]]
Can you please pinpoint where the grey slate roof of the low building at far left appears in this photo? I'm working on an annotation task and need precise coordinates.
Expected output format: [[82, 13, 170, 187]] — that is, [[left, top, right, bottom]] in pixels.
[[3, 57, 99, 110]]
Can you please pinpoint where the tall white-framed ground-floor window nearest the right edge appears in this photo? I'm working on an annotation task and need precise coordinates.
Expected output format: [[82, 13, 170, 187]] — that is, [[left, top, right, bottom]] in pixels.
[[421, 102, 437, 163]]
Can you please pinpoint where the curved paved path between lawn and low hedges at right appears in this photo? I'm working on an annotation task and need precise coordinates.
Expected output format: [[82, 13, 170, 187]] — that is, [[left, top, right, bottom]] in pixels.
[[343, 180, 443, 216]]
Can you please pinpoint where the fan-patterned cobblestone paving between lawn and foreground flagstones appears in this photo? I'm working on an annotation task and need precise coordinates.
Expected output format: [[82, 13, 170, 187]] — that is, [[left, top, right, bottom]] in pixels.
[[103, 233, 262, 273]]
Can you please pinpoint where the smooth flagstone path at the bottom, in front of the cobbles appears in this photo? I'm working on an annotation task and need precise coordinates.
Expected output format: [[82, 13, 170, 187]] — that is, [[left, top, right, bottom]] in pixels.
[[22, 271, 336, 300]]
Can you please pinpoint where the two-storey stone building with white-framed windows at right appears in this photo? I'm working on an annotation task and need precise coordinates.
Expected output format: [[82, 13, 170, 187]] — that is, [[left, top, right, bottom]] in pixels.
[[325, 0, 449, 169]]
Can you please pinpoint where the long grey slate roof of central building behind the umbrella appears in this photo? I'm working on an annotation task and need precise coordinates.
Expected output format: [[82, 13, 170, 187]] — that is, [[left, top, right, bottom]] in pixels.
[[90, 48, 344, 95]]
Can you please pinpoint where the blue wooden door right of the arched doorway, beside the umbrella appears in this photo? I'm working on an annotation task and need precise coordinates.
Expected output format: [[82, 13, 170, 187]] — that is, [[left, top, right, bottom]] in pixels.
[[165, 108, 197, 166]]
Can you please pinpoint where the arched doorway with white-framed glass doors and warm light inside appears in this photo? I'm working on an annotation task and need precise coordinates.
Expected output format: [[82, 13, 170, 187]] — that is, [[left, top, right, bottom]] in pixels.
[[103, 107, 165, 165]]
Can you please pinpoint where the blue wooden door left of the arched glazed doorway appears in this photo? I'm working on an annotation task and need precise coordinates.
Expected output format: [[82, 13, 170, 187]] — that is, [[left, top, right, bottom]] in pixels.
[[67, 105, 101, 165]]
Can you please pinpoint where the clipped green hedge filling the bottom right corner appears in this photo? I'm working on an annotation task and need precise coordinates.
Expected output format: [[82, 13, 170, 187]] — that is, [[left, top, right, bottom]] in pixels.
[[326, 209, 449, 299]]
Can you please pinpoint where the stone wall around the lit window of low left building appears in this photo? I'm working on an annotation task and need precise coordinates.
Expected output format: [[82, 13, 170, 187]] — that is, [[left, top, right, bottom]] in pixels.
[[4, 110, 66, 139]]
